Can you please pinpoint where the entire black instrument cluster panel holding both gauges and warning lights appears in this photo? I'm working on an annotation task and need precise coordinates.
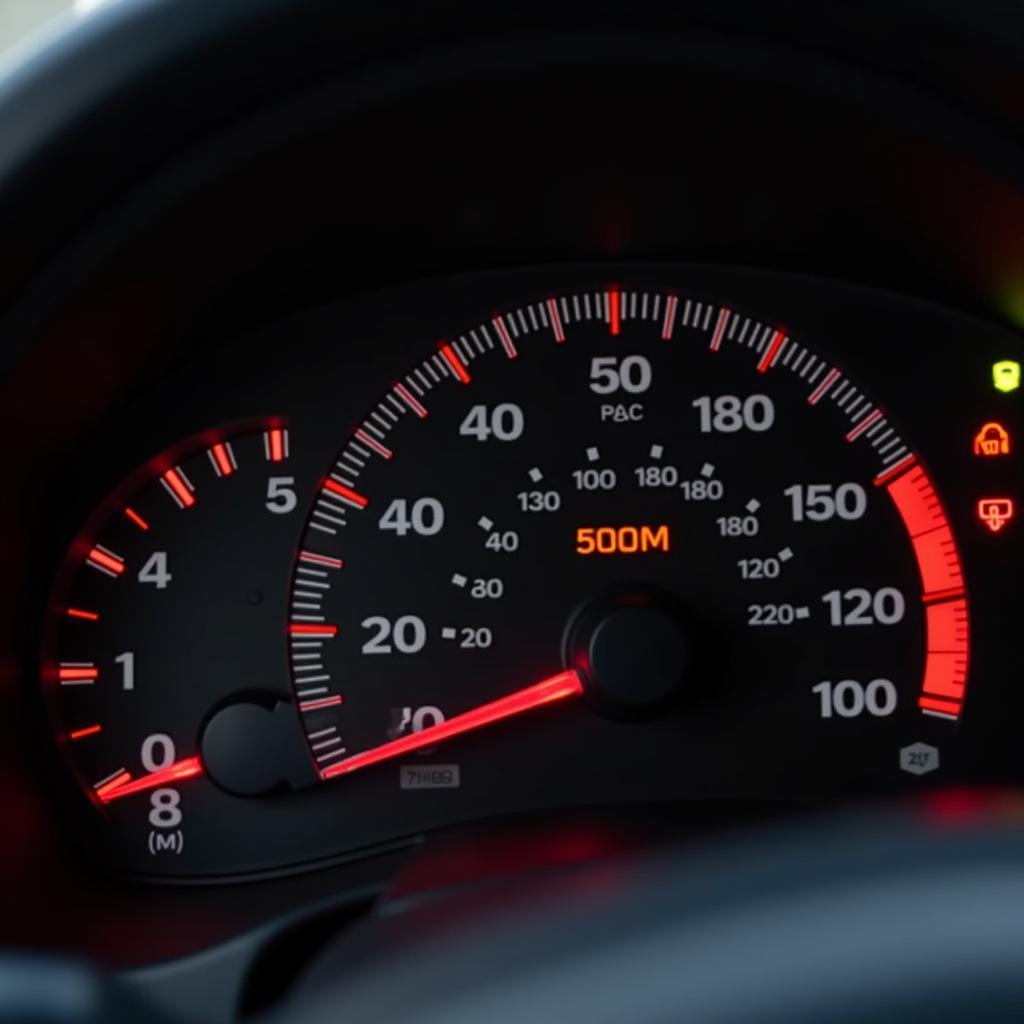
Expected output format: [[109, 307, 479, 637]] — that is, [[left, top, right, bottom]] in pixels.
[[36, 271, 1021, 878]]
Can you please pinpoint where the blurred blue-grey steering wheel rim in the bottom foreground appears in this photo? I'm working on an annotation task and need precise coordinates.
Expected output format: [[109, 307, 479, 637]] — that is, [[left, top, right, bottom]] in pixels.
[[280, 814, 1024, 1024]]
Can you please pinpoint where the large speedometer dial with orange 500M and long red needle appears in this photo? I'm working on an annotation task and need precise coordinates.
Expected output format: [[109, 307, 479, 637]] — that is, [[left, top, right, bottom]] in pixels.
[[289, 287, 970, 785]]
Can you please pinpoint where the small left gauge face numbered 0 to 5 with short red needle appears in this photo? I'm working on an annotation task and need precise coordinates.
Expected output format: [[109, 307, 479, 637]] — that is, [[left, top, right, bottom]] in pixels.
[[43, 423, 315, 867]]
